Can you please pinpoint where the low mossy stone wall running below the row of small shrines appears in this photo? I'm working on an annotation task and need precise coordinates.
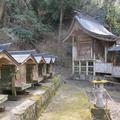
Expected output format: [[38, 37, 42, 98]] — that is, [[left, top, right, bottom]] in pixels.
[[11, 77, 60, 120]]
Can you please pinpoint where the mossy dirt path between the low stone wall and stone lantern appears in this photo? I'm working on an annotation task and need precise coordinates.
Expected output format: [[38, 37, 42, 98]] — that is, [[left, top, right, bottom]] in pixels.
[[39, 81, 90, 120]]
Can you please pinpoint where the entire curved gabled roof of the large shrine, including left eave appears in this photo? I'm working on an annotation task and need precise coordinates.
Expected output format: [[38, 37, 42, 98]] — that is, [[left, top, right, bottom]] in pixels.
[[63, 12, 117, 41]]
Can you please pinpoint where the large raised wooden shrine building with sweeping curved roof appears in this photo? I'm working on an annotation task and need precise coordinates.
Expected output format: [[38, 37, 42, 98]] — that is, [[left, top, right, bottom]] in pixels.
[[63, 12, 117, 77]]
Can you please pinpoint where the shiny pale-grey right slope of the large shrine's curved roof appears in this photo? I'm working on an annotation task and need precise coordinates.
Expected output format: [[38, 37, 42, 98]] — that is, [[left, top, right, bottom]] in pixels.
[[75, 14, 117, 41]]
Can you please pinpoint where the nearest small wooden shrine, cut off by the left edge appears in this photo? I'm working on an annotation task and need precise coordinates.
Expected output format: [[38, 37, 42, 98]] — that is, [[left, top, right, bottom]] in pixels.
[[0, 50, 19, 89]]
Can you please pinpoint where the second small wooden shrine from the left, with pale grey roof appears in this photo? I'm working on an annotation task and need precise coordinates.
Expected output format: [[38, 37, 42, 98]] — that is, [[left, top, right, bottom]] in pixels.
[[9, 51, 38, 89]]
